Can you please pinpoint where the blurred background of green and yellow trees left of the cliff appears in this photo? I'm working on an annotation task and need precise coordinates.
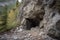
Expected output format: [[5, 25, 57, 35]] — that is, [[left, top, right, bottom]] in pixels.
[[0, 0, 19, 32]]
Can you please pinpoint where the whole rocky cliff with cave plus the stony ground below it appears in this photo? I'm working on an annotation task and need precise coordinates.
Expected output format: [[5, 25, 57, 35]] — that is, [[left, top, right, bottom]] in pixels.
[[0, 0, 60, 40]]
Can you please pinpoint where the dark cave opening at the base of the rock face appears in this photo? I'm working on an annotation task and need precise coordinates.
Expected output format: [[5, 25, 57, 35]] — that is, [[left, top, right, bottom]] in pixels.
[[26, 18, 40, 30]]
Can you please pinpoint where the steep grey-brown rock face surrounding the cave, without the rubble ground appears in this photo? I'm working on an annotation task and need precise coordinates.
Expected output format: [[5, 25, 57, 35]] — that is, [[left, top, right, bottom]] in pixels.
[[21, 0, 60, 40]]
